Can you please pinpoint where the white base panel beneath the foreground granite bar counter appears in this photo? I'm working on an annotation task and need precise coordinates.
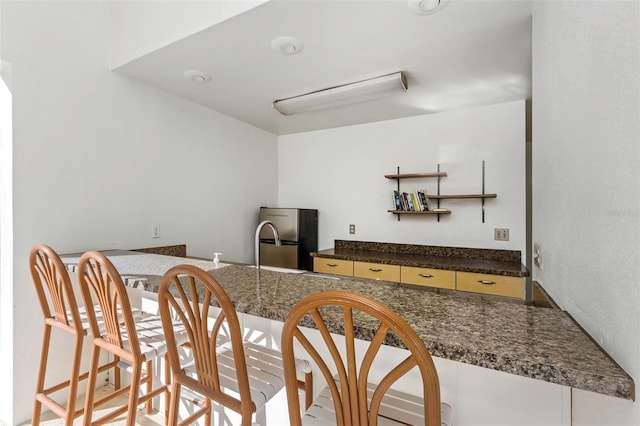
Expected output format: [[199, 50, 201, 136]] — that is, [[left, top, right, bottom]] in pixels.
[[241, 314, 568, 426]]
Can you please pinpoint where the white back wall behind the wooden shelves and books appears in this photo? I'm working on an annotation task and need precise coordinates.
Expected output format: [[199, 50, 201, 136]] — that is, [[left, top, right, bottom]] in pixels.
[[278, 101, 525, 253]]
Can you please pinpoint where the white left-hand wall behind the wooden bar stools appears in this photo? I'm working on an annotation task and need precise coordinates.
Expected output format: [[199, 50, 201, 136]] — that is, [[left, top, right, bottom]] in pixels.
[[0, 1, 277, 424]]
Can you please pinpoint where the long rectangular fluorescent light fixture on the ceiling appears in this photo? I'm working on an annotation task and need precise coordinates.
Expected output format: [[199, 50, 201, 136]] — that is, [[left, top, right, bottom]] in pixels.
[[273, 72, 407, 115]]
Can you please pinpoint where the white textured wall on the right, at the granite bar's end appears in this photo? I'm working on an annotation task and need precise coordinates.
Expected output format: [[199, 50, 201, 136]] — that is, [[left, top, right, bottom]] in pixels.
[[532, 1, 640, 425]]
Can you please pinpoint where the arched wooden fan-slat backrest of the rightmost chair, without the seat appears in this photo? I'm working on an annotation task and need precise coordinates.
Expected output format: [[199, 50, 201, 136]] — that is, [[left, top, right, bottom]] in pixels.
[[282, 290, 441, 426]]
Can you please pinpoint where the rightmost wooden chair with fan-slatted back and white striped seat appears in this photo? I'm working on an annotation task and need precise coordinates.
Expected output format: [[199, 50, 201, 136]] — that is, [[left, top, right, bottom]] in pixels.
[[282, 290, 452, 426]]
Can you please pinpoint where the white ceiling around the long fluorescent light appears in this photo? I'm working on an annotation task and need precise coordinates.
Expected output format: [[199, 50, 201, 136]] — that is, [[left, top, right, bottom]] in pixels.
[[116, 0, 532, 135]]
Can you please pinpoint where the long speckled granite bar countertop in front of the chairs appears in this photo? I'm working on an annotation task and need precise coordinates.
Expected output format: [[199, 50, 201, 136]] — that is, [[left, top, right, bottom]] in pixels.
[[62, 251, 635, 399]]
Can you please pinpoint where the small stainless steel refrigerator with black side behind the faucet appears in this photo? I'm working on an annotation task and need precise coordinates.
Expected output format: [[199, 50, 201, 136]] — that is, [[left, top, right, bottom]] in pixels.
[[260, 207, 318, 271]]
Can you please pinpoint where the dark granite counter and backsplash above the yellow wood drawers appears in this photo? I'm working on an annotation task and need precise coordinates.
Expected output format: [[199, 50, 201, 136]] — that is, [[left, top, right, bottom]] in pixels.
[[311, 240, 529, 277]]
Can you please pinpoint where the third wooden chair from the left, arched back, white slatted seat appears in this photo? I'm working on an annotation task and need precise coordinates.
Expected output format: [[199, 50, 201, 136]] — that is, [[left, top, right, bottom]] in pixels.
[[158, 265, 312, 426]]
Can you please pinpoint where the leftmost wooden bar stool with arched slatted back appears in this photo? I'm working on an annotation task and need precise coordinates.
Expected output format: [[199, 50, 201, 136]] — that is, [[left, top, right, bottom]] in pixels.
[[29, 244, 119, 425]]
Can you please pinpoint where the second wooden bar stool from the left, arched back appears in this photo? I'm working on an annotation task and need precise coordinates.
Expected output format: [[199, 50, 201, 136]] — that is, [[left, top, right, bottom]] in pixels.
[[78, 251, 178, 426]]
